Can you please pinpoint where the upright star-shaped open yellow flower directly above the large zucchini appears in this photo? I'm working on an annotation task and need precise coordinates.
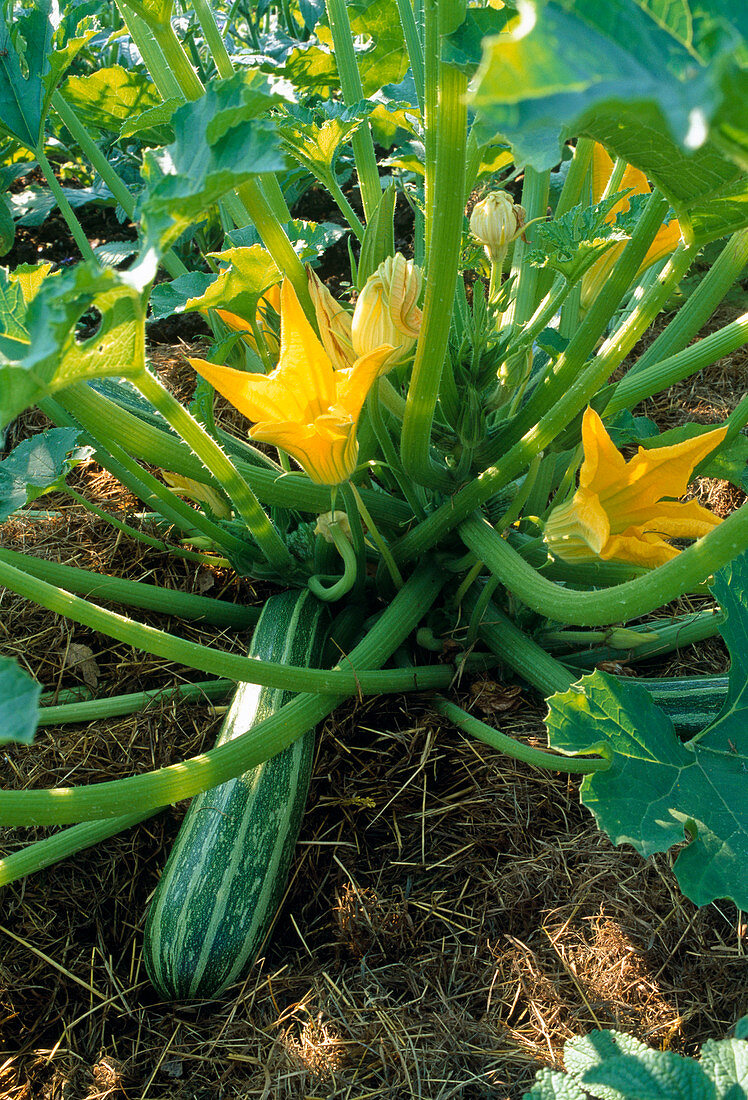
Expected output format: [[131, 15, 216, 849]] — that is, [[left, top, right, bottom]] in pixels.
[[189, 281, 393, 485]]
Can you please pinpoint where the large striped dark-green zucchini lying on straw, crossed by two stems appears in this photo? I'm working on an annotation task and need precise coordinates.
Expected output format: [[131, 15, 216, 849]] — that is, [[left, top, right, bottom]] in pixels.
[[144, 591, 329, 1000]]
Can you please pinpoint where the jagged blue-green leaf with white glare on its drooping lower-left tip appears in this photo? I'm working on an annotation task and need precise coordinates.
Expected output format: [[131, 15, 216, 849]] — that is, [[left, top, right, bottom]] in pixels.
[[137, 72, 285, 252]]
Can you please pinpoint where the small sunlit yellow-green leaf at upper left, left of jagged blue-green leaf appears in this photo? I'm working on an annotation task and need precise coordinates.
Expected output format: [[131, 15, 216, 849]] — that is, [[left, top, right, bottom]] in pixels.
[[63, 65, 162, 133]]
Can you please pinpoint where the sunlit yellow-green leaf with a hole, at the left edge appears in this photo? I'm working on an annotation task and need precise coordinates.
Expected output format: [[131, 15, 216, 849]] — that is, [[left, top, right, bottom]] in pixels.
[[0, 256, 155, 428]]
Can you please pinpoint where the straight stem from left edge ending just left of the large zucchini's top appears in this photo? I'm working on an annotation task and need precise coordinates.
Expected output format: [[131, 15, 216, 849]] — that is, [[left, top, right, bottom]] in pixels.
[[0, 549, 260, 630]]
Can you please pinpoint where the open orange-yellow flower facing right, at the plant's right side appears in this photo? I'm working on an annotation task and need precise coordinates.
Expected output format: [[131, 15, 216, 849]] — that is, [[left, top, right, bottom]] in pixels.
[[543, 408, 727, 568]]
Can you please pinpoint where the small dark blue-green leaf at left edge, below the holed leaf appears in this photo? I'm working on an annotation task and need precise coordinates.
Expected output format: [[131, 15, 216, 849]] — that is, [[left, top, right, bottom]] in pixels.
[[0, 428, 91, 523]]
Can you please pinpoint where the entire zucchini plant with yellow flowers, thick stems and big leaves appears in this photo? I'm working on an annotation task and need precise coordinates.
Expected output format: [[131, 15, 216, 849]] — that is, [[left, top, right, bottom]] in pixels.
[[0, 0, 748, 996]]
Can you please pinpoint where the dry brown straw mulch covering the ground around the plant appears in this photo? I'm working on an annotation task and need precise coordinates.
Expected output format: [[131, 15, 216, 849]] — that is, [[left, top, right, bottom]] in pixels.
[[0, 321, 748, 1100]]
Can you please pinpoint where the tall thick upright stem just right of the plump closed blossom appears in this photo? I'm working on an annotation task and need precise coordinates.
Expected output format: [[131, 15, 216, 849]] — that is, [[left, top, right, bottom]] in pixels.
[[400, 63, 468, 490]]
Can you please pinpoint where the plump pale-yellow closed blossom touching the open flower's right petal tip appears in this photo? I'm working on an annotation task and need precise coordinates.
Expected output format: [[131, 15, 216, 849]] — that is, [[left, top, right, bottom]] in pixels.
[[352, 252, 424, 365]]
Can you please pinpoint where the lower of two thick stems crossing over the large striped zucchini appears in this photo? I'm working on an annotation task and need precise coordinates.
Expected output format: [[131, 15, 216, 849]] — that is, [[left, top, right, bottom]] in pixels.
[[0, 563, 443, 825]]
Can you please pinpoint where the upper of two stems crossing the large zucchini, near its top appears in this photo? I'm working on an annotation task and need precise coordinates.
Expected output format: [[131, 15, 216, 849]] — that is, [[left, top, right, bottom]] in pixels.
[[0, 560, 453, 695]]
